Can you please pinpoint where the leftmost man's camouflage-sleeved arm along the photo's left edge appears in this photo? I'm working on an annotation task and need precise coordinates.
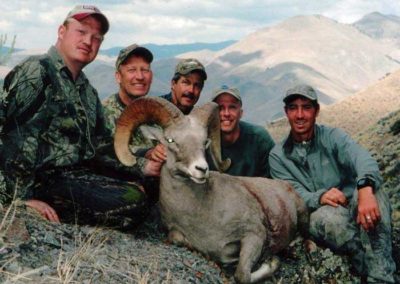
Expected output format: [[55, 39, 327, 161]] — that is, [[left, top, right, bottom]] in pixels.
[[2, 58, 44, 200]]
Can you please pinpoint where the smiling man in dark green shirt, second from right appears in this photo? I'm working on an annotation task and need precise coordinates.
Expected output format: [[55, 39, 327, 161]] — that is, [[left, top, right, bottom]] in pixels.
[[208, 85, 275, 177]]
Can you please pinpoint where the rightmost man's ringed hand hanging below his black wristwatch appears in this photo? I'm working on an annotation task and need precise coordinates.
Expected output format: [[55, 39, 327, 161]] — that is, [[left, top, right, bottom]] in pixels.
[[357, 186, 381, 231]]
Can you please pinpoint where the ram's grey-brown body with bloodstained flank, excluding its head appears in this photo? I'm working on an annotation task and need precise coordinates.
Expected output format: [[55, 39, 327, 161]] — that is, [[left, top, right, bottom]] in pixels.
[[160, 168, 308, 282]]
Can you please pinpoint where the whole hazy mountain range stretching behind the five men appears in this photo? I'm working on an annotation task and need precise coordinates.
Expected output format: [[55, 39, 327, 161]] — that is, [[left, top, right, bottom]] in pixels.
[[0, 13, 400, 125]]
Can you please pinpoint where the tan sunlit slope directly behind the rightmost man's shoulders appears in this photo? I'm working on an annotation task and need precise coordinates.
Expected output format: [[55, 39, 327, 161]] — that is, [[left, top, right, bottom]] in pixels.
[[267, 70, 400, 141]]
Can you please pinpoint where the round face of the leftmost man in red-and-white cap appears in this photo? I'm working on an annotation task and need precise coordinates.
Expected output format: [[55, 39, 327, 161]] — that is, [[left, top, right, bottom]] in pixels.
[[58, 16, 103, 67]]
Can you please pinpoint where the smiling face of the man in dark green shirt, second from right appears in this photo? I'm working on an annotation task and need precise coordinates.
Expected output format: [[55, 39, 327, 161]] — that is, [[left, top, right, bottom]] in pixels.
[[215, 93, 243, 134]]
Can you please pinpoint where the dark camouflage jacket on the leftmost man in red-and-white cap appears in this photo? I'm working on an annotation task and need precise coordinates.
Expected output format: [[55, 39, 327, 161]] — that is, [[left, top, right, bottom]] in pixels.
[[0, 47, 144, 199]]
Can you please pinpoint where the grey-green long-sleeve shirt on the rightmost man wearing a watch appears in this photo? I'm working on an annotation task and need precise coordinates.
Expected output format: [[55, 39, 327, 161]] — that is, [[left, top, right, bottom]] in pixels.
[[269, 125, 382, 210]]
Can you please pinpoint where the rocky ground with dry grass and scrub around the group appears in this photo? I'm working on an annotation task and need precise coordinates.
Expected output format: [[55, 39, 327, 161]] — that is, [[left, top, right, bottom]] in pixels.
[[0, 111, 400, 283]]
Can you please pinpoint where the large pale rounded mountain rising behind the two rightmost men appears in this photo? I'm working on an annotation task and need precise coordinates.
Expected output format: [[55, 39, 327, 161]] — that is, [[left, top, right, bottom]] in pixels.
[[192, 16, 400, 123]]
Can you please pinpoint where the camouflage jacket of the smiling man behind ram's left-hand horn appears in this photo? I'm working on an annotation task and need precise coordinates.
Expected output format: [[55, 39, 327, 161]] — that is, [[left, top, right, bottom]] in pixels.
[[103, 93, 157, 160]]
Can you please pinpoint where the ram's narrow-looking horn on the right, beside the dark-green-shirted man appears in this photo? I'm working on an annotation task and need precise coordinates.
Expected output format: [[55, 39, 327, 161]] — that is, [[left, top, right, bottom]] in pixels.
[[190, 102, 231, 172]]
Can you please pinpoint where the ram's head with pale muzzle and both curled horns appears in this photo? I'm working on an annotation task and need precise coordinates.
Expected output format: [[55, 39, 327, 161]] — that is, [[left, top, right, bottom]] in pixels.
[[114, 97, 230, 183]]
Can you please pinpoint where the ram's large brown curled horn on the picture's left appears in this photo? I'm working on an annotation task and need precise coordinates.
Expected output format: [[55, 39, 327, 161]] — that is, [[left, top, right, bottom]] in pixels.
[[114, 97, 183, 166]]
